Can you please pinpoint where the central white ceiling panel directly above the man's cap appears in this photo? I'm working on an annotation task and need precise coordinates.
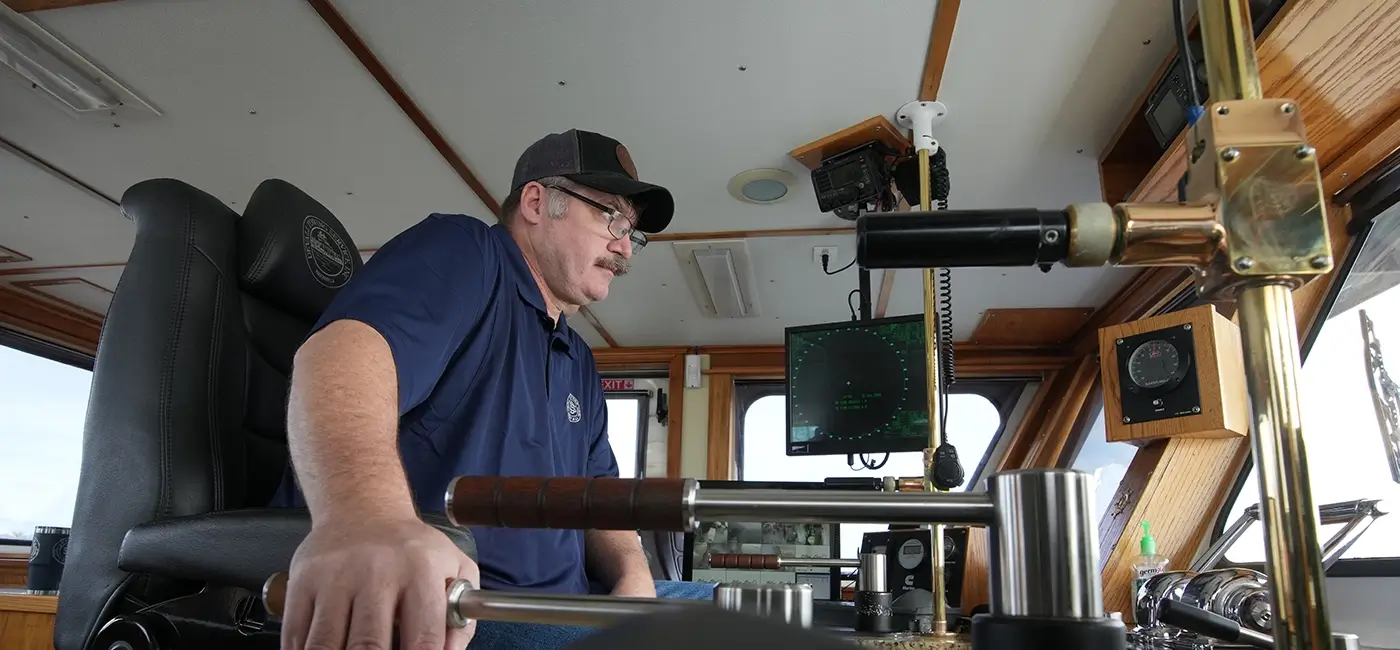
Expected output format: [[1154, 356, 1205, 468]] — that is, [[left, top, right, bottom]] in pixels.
[[336, 0, 937, 231]]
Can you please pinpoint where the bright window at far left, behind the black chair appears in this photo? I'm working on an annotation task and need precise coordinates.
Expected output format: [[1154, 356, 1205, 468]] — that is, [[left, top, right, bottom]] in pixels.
[[0, 331, 92, 545]]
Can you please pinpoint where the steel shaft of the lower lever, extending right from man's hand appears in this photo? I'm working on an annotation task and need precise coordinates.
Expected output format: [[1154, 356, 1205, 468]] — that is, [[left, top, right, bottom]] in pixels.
[[448, 580, 700, 628]]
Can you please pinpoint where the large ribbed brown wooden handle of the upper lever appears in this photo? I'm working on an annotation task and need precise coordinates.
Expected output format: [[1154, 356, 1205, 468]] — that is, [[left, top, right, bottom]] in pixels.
[[447, 476, 696, 531]]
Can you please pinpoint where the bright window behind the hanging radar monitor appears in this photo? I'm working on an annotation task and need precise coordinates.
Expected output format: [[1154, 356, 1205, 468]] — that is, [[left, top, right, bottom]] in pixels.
[[735, 382, 1025, 558]]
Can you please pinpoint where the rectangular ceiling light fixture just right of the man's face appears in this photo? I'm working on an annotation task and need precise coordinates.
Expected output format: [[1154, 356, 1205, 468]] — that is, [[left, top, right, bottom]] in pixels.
[[672, 240, 759, 318]]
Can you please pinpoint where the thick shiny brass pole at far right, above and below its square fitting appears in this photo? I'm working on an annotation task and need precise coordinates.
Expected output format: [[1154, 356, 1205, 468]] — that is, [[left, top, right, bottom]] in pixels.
[[1197, 0, 1331, 650]]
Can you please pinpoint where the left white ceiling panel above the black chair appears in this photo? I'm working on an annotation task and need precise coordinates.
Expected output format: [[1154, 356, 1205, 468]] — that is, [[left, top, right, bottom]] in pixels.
[[0, 0, 487, 262]]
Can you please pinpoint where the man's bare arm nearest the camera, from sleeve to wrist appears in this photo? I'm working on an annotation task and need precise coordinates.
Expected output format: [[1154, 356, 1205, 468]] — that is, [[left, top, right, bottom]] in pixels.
[[287, 321, 414, 521]]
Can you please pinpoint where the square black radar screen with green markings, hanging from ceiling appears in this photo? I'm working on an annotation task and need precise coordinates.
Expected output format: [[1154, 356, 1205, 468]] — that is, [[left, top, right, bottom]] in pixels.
[[787, 315, 928, 455]]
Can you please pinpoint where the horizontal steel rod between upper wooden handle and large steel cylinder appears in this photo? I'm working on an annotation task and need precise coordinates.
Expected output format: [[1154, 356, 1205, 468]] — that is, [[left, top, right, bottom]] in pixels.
[[692, 489, 993, 524]]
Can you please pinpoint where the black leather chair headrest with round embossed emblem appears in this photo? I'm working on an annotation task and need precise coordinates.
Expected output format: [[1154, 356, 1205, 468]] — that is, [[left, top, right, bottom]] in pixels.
[[238, 178, 364, 321]]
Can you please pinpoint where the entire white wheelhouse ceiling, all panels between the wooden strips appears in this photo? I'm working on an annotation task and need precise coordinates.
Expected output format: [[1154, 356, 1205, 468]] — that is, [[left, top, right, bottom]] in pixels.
[[0, 0, 1172, 347]]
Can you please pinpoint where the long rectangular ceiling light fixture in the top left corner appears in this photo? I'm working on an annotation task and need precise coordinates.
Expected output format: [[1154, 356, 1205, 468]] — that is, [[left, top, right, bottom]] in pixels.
[[0, 3, 160, 118]]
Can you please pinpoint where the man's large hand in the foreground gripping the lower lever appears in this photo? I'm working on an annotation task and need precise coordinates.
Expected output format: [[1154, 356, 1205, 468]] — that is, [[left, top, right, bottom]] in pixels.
[[281, 517, 482, 650]]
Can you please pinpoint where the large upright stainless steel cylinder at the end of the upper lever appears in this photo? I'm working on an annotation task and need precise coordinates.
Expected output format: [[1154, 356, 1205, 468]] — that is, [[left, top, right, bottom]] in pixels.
[[987, 469, 1103, 619]]
